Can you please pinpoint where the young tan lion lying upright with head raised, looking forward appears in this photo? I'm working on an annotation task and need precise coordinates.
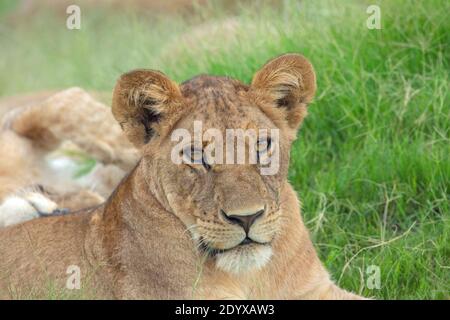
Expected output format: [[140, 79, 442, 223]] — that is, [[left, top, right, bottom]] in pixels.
[[0, 54, 362, 299]]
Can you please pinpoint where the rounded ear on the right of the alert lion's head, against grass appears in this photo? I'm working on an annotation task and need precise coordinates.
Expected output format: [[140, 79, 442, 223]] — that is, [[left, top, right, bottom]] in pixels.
[[251, 54, 316, 129]]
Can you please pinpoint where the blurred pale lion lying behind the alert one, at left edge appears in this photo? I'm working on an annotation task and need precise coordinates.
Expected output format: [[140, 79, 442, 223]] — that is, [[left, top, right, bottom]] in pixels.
[[0, 88, 138, 227]]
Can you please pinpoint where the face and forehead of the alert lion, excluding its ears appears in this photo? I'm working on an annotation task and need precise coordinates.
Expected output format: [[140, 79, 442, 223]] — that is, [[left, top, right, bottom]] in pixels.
[[146, 76, 289, 272]]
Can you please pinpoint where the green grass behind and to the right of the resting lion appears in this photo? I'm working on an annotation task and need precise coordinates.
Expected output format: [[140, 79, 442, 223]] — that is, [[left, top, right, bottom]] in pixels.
[[0, 0, 450, 299]]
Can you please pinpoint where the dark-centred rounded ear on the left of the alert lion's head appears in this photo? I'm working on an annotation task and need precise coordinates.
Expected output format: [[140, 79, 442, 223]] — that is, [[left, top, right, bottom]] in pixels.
[[112, 69, 181, 148]]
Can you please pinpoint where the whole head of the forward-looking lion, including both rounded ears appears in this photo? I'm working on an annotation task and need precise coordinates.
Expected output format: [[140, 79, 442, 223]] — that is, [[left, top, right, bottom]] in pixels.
[[112, 54, 316, 273]]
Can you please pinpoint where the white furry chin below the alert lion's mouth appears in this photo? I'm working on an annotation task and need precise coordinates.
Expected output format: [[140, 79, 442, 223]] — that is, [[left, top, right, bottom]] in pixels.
[[216, 244, 272, 274]]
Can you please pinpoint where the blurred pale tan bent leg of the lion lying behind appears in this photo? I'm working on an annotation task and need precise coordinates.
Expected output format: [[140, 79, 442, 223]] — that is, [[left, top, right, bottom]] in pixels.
[[3, 88, 138, 171]]
